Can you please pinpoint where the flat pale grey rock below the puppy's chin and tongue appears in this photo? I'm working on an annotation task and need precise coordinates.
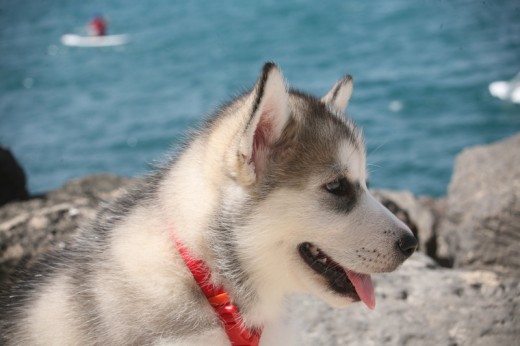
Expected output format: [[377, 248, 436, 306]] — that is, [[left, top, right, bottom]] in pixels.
[[289, 253, 520, 346]]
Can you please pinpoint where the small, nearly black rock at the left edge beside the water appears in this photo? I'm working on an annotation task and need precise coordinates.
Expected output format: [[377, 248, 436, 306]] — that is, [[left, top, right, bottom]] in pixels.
[[0, 147, 29, 206]]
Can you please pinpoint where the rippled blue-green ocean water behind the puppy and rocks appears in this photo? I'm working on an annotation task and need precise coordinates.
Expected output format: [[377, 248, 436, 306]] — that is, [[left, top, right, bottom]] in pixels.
[[0, 0, 520, 196]]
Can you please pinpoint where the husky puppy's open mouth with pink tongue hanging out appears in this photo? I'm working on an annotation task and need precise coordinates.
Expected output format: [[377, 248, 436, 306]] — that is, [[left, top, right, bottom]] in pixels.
[[298, 242, 376, 309]]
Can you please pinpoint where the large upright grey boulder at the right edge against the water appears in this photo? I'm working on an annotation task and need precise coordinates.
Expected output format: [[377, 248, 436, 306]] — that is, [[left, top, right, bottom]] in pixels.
[[439, 134, 520, 274]]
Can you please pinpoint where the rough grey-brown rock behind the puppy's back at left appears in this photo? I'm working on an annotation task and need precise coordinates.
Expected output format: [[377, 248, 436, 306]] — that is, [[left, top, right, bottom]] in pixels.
[[0, 175, 134, 282]]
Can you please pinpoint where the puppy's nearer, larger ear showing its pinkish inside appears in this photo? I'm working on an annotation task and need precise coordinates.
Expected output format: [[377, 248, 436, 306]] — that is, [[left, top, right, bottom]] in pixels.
[[238, 62, 289, 184]]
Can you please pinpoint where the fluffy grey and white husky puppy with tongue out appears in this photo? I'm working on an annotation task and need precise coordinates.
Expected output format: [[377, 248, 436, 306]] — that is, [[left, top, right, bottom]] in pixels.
[[0, 63, 417, 345]]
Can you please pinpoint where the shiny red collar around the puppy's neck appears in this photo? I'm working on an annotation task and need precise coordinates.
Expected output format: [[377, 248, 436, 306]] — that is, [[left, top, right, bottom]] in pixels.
[[170, 227, 262, 346]]
